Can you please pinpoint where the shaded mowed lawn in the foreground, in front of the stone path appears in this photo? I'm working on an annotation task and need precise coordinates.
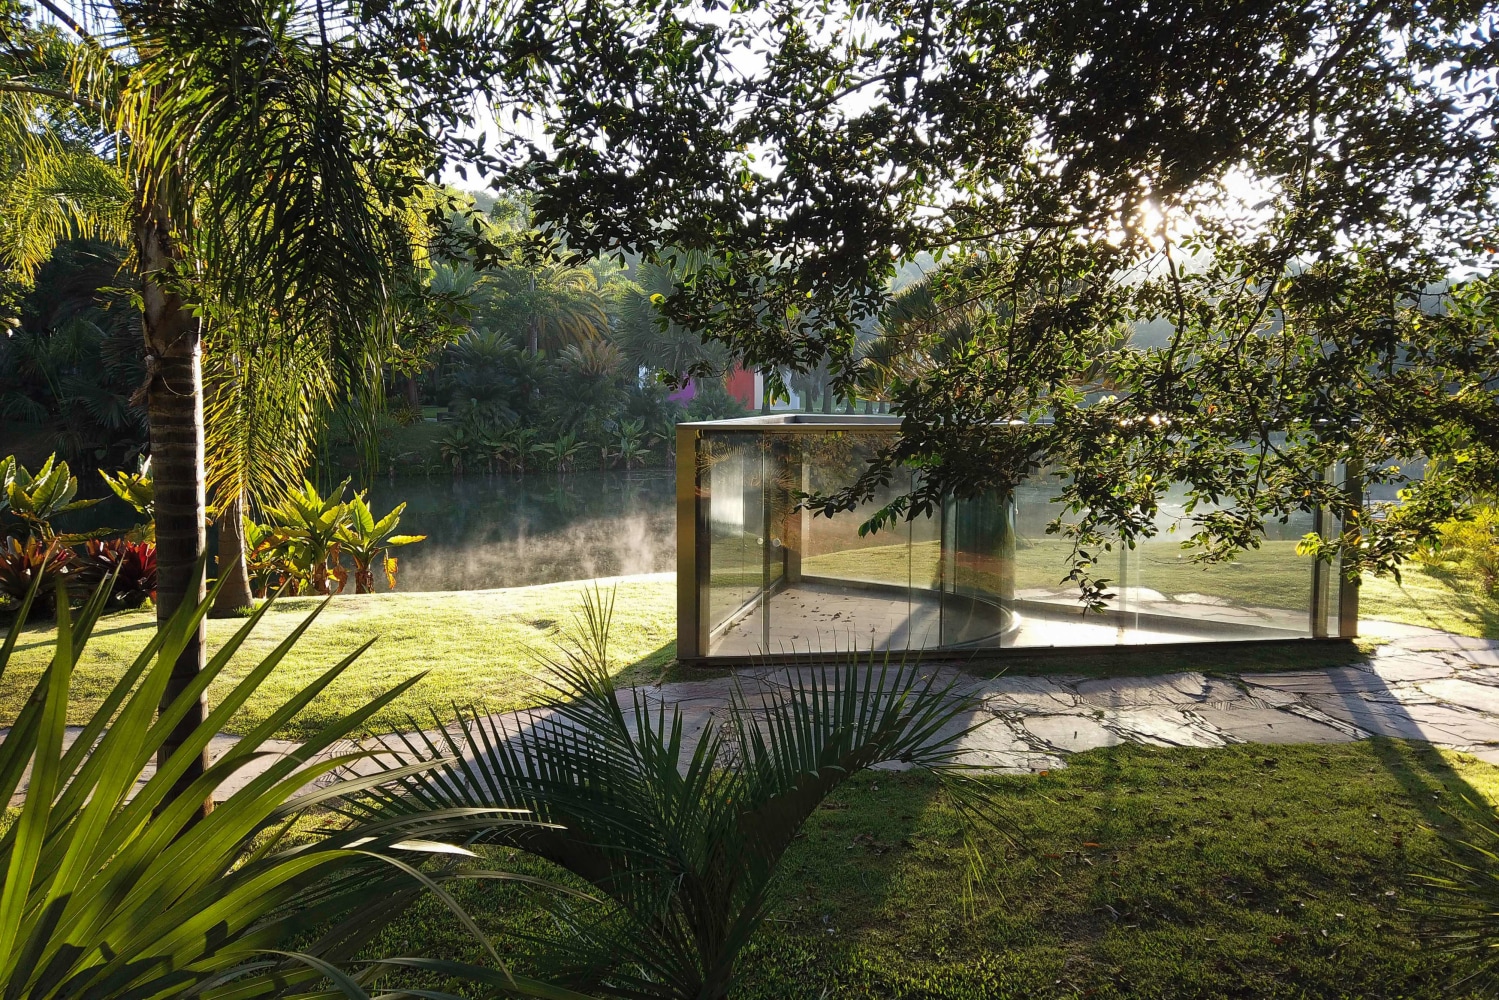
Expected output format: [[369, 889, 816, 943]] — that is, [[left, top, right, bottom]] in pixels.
[[370, 741, 1499, 1000]]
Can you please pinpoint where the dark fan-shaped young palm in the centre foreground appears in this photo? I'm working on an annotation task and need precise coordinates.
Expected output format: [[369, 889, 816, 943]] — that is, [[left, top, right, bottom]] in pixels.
[[351, 591, 973, 1000]]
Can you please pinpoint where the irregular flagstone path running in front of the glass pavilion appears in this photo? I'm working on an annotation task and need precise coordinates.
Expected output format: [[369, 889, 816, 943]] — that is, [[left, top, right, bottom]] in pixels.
[[11, 622, 1499, 795]]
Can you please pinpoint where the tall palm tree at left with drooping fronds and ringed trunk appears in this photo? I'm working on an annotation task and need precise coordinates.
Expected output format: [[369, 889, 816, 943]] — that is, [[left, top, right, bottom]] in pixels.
[[0, 0, 473, 808]]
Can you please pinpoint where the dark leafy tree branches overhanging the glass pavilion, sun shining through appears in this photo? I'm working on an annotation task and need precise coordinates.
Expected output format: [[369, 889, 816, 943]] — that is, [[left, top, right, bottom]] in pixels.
[[479, 0, 1499, 597]]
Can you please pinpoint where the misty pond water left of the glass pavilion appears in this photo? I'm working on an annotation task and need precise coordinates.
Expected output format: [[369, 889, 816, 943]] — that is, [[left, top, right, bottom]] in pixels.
[[362, 469, 676, 591]]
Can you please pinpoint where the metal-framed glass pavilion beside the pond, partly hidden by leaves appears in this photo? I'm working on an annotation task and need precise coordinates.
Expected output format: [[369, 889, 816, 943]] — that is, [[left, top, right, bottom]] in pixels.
[[678, 414, 1357, 660]]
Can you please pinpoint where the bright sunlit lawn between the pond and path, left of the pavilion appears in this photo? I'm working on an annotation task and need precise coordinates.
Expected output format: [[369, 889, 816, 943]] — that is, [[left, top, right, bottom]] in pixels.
[[0, 576, 676, 739]]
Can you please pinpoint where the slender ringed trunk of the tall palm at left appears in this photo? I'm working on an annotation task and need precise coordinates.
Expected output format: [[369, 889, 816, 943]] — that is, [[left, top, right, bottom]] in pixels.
[[136, 205, 213, 814]]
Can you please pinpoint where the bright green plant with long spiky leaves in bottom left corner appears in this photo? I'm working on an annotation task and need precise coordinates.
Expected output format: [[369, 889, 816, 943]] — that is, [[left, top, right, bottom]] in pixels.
[[0, 566, 578, 1000]]
